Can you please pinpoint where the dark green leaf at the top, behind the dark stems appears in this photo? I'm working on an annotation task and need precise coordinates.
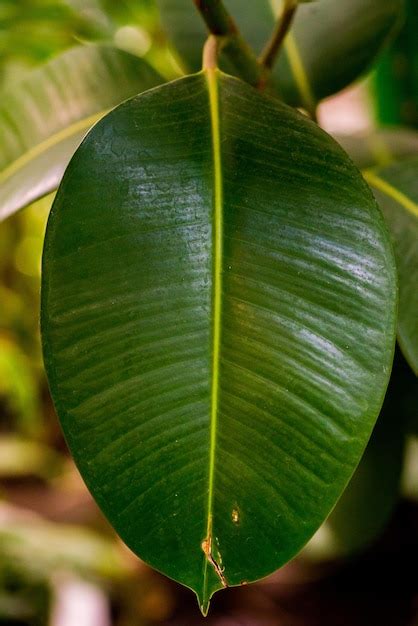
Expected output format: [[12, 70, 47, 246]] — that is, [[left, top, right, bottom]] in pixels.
[[158, 0, 403, 109]]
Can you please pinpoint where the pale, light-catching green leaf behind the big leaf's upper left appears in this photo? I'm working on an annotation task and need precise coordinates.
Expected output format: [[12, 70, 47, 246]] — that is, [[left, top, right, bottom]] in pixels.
[[0, 45, 164, 219]]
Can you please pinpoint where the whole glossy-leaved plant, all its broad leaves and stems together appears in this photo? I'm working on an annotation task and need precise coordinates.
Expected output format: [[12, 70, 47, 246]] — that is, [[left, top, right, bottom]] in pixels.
[[0, 0, 418, 614]]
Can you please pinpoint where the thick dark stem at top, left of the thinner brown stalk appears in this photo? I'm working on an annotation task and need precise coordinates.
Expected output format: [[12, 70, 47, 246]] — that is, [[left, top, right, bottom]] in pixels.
[[193, 0, 266, 87]]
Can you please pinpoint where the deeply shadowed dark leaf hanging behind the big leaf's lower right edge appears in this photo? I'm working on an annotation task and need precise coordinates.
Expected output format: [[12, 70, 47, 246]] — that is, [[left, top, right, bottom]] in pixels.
[[304, 351, 418, 560]]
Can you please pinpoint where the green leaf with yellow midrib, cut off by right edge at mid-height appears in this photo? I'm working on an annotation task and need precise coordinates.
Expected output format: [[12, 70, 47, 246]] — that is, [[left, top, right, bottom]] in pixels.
[[365, 157, 418, 375]]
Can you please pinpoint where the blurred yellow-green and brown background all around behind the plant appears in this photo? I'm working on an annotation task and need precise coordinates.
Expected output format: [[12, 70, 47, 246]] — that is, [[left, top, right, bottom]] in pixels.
[[0, 0, 418, 626]]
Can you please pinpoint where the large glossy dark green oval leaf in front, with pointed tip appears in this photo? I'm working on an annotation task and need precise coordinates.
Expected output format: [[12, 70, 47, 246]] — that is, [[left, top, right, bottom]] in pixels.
[[42, 71, 396, 611]]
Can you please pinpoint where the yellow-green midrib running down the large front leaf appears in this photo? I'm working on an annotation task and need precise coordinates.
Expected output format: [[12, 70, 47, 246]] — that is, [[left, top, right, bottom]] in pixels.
[[203, 68, 223, 602]]
